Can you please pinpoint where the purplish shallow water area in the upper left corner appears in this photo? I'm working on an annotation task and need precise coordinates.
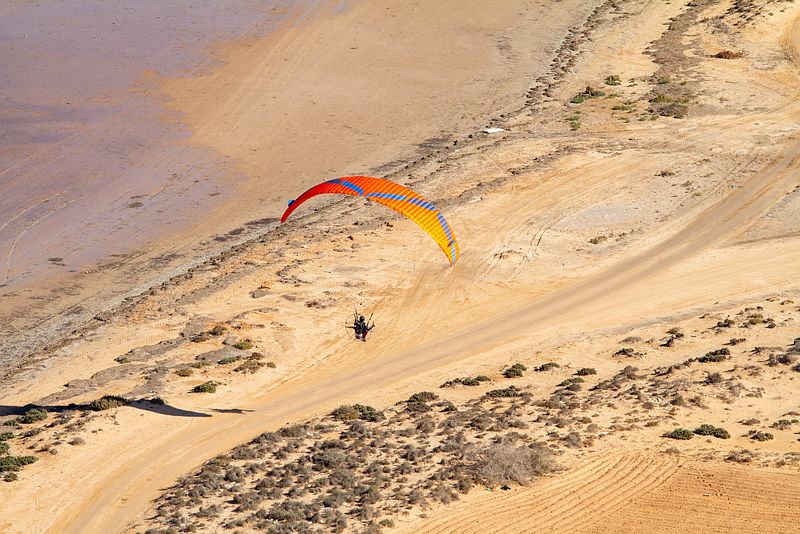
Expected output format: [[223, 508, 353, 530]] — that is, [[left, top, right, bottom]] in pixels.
[[0, 0, 317, 291]]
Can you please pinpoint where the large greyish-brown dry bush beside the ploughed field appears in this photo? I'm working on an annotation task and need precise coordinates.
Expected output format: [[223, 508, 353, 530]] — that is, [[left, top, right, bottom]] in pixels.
[[469, 444, 558, 486]]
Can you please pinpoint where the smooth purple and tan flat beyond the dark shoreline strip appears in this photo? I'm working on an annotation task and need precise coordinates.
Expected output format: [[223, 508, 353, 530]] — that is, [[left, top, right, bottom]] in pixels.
[[0, 1, 592, 376]]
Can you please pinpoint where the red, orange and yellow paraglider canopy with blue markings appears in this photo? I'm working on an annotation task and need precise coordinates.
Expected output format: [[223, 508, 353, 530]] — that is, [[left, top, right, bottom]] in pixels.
[[281, 176, 460, 265]]
